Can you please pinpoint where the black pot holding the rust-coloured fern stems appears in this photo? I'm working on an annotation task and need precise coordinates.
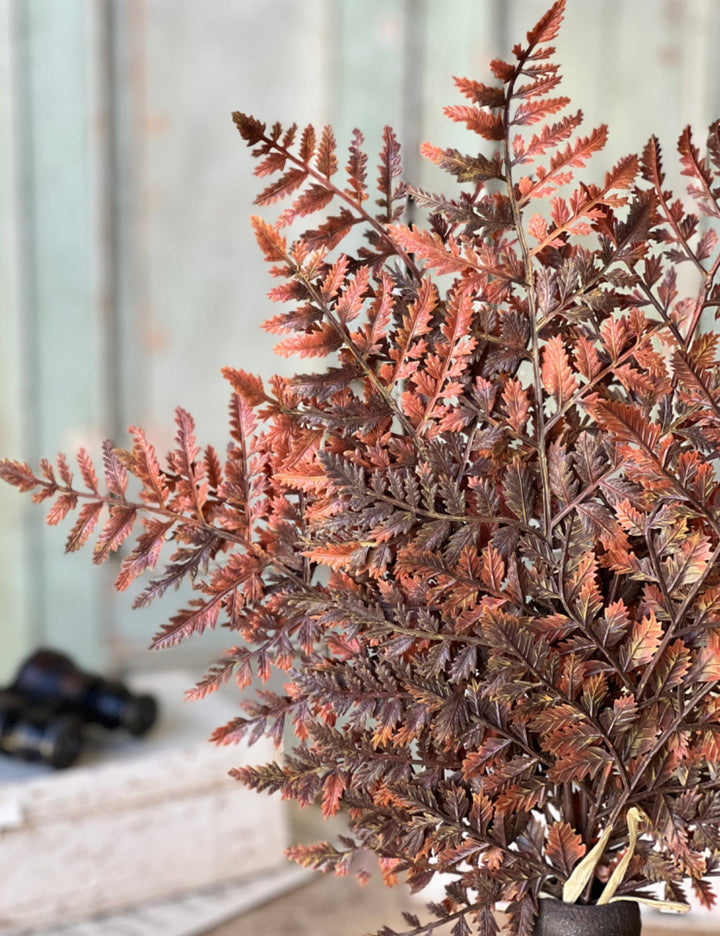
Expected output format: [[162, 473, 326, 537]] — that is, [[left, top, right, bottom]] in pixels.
[[533, 899, 640, 936]]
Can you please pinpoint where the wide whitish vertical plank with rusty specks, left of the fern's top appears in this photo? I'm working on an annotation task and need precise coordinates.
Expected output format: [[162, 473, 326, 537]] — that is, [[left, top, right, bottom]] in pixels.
[[105, 0, 329, 666]]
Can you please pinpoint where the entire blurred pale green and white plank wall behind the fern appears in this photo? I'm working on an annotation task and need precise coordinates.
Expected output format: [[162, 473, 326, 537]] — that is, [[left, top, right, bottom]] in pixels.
[[0, 0, 720, 678]]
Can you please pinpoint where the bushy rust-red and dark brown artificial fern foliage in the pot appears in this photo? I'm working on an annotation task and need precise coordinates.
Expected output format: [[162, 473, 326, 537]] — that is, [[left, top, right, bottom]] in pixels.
[[1, 2, 720, 936]]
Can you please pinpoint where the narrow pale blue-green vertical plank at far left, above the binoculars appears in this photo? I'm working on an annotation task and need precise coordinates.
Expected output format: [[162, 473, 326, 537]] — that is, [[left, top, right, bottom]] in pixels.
[[9, 0, 101, 662]]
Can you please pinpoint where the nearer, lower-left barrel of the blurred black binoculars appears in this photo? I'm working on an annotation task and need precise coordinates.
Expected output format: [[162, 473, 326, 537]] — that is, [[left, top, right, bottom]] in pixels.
[[0, 689, 83, 769]]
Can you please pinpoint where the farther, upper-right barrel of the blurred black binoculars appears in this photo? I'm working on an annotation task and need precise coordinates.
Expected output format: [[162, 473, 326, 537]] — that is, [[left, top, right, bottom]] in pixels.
[[11, 649, 157, 736]]
